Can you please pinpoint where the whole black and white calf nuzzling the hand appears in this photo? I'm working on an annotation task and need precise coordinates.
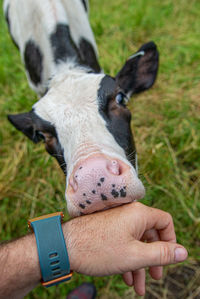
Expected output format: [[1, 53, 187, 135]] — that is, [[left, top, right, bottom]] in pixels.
[[4, 0, 158, 216]]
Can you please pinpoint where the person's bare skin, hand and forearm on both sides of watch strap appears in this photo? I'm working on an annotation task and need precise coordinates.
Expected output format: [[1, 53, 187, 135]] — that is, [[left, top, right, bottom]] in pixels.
[[0, 202, 187, 299]]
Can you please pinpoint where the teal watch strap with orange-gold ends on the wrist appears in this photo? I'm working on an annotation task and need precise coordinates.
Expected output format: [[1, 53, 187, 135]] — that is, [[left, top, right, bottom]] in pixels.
[[29, 213, 72, 287]]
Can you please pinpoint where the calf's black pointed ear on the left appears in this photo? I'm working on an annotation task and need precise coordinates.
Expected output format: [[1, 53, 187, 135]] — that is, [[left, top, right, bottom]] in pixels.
[[8, 112, 40, 143]]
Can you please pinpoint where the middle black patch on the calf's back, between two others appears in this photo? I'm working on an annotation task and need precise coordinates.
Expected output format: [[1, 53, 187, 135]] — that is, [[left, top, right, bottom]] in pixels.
[[50, 24, 80, 63]]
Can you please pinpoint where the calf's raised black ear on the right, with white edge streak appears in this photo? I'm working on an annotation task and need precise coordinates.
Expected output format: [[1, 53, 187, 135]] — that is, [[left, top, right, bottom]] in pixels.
[[116, 42, 159, 97]]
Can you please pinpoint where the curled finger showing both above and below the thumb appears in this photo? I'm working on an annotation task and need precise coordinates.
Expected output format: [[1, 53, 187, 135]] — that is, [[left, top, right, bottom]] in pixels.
[[143, 229, 163, 280]]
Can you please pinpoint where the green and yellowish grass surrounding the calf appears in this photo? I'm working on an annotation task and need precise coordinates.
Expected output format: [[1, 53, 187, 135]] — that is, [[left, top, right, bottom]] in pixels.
[[0, 0, 200, 299]]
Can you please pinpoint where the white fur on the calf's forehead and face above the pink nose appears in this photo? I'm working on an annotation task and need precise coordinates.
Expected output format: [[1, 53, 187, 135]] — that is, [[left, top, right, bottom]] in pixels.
[[34, 69, 136, 186]]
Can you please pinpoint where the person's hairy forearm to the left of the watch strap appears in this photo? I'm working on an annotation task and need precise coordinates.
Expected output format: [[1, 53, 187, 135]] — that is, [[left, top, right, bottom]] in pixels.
[[0, 234, 41, 299]]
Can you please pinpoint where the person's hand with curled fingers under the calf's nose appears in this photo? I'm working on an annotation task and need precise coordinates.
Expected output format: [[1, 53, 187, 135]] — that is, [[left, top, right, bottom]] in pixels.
[[63, 202, 187, 295]]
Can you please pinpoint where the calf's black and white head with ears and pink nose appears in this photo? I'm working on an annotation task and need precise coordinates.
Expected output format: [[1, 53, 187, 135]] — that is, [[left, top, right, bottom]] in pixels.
[[8, 42, 158, 217]]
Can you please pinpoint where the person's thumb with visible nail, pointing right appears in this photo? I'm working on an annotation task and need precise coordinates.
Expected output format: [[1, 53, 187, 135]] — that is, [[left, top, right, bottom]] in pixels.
[[133, 241, 188, 268]]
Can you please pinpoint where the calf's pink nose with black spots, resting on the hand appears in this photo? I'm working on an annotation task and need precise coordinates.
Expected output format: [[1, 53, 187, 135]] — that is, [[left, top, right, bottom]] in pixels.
[[66, 155, 144, 216]]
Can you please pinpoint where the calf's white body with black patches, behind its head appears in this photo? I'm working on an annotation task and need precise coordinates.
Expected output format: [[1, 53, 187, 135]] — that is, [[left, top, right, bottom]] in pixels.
[[5, 0, 101, 95]]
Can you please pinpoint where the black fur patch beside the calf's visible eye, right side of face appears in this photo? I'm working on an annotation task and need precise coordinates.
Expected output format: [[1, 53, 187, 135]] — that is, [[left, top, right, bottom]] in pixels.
[[98, 75, 136, 167]]
